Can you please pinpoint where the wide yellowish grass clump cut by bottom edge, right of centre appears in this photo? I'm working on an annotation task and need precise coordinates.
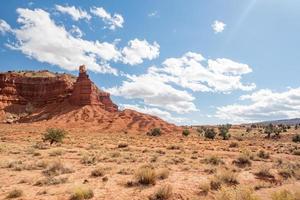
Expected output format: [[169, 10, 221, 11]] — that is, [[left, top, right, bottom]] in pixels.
[[215, 186, 259, 200]]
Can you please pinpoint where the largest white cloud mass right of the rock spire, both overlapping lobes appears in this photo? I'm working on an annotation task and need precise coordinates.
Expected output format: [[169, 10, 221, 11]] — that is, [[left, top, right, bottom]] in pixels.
[[108, 52, 255, 113]]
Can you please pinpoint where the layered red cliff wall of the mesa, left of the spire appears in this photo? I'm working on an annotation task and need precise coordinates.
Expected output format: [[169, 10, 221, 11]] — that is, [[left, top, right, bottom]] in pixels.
[[0, 71, 73, 105]]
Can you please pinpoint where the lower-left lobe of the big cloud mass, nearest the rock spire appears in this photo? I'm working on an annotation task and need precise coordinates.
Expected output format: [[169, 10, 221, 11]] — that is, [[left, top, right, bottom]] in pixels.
[[107, 73, 197, 113]]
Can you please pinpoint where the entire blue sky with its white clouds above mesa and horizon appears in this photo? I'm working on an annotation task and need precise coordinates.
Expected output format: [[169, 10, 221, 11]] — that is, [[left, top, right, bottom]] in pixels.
[[0, 0, 300, 124]]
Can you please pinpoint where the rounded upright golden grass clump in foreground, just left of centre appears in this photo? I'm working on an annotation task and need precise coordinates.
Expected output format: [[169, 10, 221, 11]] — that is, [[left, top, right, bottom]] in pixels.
[[135, 165, 156, 185]]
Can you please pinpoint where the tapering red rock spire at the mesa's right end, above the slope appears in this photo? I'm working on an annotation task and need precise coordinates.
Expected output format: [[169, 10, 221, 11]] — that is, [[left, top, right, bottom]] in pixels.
[[70, 65, 118, 112]]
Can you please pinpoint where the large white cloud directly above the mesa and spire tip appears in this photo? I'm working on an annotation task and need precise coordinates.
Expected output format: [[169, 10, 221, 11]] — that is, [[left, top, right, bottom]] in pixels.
[[8, 8, 120, 74]]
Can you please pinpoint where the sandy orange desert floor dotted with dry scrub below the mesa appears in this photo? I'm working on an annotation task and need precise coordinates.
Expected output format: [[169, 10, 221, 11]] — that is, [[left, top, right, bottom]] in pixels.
[[0, 124, 300, 200]]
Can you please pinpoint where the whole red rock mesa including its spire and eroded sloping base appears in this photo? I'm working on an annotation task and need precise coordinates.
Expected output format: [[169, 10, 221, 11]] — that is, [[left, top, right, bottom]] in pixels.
[[0, 66, 178, 132]]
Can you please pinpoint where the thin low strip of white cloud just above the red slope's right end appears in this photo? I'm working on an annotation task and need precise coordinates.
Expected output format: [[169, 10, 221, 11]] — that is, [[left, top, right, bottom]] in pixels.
[[122, 104, 187, 124]]
